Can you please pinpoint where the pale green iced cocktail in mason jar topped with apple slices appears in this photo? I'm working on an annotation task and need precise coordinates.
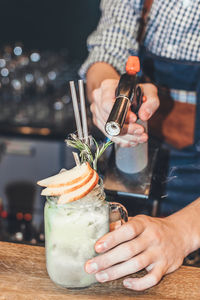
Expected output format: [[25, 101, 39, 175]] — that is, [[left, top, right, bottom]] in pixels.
[[39, 163, 127, 288]]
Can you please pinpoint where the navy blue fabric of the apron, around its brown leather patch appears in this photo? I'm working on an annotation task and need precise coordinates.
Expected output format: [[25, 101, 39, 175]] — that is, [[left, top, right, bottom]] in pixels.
[[140, 47, 200, 215]]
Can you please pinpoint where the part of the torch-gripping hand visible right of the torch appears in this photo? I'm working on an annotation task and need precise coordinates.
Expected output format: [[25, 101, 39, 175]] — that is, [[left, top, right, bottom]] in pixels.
[[138, 83, 160, 121]]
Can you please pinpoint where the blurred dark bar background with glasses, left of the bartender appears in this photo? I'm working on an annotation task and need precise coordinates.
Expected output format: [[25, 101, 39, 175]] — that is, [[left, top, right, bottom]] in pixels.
[[0, 0, 103, 245]]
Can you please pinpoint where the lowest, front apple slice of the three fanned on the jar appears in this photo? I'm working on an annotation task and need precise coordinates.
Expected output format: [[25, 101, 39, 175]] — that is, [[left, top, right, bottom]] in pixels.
[[58, 171, 99, 204]]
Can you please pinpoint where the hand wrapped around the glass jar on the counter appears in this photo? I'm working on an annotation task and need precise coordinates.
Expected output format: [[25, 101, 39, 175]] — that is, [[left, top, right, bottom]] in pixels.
[[85, 214, 191, 291]]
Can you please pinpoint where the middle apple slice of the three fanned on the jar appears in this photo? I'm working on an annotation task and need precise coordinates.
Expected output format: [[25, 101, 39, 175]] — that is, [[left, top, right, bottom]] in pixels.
[[41, 168, 94, 196]]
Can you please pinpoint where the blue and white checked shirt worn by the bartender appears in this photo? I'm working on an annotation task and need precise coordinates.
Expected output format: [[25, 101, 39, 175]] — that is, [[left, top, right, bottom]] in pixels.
[[79, 0, 200, 103]]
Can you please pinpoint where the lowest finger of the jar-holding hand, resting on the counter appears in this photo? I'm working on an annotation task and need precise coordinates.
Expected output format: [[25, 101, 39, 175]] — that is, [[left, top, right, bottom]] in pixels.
[[123, 264, 165, 291]]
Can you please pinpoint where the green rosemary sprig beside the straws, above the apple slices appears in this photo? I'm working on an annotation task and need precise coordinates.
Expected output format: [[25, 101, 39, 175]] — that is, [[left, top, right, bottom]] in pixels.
[[65, 133, 113, 170]]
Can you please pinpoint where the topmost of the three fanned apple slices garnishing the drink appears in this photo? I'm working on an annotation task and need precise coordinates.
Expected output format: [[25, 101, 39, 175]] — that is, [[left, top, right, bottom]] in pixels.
[[37, 162, 92, 187]]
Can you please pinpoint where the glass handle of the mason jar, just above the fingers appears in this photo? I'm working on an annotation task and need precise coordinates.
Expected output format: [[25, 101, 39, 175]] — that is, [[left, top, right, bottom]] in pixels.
[[109, 202, 128, 231]]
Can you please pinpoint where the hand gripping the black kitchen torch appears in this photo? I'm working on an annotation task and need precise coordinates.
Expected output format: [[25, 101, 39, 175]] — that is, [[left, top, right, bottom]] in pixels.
[[91, 79, 159, 147]]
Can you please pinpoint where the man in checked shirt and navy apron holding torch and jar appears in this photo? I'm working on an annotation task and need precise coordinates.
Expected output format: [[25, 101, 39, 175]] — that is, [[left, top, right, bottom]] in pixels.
[[80, 0, 200, 290]]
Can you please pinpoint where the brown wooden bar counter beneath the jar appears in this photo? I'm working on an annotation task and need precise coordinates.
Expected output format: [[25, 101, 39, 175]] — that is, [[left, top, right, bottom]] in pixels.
[[0, 242, 200, 300]]
